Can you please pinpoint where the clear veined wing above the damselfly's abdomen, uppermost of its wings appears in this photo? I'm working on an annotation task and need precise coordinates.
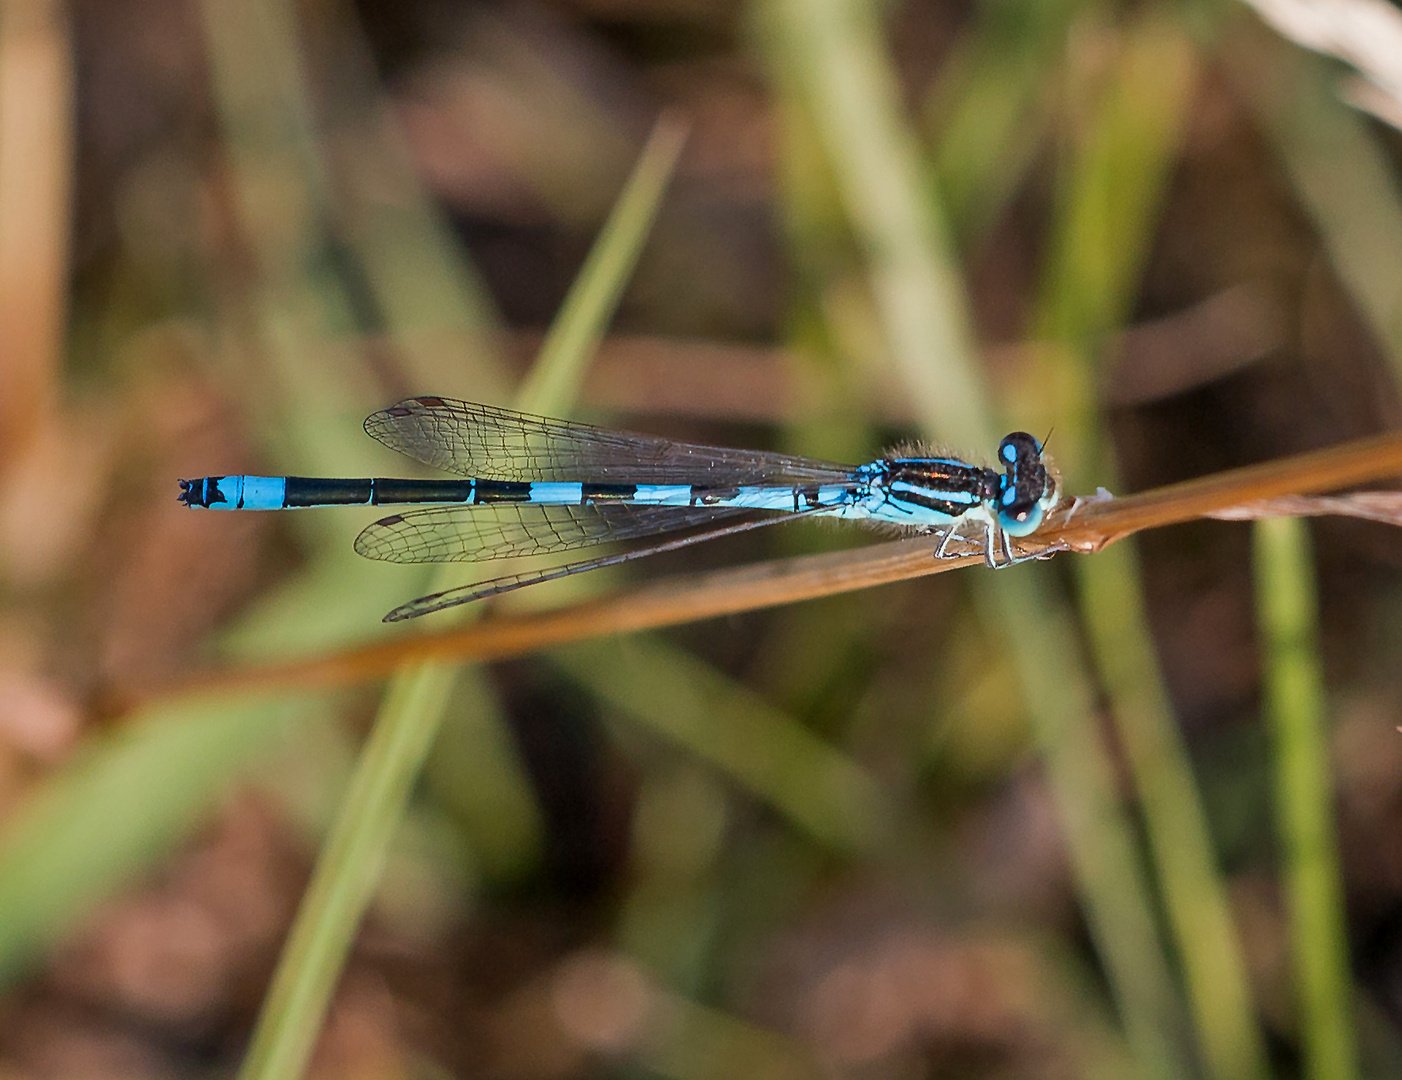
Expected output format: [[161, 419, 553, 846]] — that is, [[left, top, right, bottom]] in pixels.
[[365, 397, 852, 487]]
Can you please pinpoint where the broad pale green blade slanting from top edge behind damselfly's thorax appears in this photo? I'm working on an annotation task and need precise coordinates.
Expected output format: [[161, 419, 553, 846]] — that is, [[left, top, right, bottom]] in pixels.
[[760, 0, 1190, 1076]]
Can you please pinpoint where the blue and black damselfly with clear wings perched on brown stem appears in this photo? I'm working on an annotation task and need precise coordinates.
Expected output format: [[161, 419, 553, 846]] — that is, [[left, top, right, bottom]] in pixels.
[[179, 397, 1059, 621]]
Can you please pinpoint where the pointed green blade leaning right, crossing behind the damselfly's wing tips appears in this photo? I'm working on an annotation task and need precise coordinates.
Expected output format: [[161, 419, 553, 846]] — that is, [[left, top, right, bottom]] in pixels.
[[240, 113, 680, 1080]]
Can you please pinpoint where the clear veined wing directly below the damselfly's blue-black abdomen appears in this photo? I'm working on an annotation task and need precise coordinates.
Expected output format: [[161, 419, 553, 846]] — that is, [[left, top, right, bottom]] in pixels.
[[355, 504, 762, 562]]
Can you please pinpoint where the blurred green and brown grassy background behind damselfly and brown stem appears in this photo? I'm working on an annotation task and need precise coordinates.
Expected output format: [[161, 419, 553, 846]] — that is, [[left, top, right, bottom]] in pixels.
[[0, 0, 1402, 1080]]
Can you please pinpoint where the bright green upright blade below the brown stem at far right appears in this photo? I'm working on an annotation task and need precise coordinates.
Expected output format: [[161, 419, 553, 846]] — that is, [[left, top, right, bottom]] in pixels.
[[1252, 518, 1359, 1080]]
